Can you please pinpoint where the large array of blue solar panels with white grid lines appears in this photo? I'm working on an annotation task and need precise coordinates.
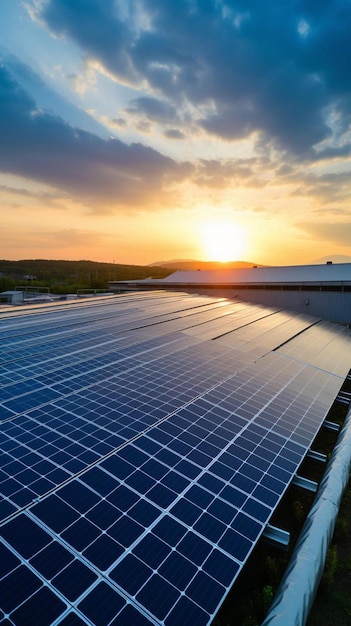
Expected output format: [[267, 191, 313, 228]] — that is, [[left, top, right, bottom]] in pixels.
[[0, 293, 351, 626]]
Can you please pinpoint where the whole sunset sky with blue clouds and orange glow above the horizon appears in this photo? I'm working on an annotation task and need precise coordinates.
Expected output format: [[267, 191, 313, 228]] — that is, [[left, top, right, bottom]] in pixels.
[[0, 0, 351, 265]]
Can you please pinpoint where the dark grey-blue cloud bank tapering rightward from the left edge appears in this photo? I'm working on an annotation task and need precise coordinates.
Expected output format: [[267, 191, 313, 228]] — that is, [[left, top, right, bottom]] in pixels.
[[0, 66, 190, 211]]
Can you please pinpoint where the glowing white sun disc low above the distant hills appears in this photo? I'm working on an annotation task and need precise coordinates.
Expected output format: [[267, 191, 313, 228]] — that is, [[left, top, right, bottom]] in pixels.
[[201, 220, 246, 263]]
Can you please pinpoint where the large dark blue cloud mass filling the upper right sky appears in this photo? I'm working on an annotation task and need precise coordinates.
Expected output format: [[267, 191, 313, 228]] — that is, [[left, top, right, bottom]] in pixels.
[[34, 0, 351, 159]]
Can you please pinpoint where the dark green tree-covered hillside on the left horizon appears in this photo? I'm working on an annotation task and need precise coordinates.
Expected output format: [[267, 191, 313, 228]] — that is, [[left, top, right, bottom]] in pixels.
[[0, 259, 171, 294]]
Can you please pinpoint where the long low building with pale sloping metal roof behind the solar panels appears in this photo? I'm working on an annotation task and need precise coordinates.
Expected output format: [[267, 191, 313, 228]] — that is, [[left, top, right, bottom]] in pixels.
[[110, 263, 351, 324]]
